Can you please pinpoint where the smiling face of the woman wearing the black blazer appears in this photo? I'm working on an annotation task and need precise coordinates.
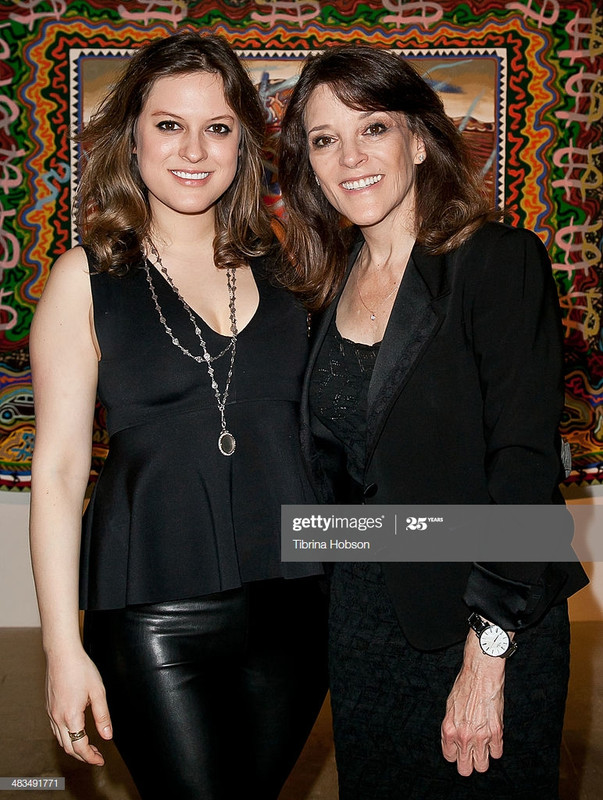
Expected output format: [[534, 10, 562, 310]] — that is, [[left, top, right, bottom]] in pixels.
[[304, 86, 425, 230]]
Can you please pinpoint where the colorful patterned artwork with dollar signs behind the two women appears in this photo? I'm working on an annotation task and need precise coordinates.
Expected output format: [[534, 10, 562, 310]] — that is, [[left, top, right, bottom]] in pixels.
[[0, 0, 603, 490]]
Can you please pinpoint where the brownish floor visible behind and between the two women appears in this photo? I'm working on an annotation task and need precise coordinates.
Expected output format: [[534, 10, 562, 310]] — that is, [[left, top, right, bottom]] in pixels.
[[0, 622, 603, 800]]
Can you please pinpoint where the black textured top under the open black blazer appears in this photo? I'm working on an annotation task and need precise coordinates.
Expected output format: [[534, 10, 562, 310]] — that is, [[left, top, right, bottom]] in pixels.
[[310, 316, 381, 483]]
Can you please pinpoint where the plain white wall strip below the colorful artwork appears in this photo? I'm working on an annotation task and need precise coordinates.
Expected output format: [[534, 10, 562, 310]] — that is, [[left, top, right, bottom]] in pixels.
[[0, 486, 603, 627]]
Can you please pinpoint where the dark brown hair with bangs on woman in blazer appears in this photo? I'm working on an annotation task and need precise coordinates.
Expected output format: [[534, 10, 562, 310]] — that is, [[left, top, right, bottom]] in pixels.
[[279, 45, 500, 310]]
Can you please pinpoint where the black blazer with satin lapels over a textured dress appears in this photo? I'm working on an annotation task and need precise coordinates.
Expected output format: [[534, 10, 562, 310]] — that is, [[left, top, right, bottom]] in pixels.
[[302, 223, 587, 650]]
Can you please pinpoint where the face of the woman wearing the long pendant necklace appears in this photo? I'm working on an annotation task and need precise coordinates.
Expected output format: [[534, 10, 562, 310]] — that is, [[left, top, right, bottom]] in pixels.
[[134, 72, 241, 219]]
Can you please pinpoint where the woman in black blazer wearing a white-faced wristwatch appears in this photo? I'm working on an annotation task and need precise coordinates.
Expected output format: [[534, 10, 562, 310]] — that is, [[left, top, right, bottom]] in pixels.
[[280, 47, 585, 800]]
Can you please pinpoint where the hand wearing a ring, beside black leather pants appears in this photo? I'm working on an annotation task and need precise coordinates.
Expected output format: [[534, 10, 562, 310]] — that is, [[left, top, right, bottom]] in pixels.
[[46, 650, 113, 766]]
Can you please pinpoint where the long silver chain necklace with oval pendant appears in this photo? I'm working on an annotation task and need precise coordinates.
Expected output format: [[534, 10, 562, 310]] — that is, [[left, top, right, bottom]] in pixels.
[[144, 239, 237, 456]]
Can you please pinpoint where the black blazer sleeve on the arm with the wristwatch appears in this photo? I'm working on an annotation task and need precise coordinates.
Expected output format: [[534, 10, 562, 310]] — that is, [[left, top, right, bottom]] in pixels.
[[464, 226, 575, 630]]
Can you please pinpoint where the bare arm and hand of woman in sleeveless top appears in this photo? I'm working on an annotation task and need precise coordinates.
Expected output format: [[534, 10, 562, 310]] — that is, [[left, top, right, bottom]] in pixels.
[[30, 248, 112, 765]]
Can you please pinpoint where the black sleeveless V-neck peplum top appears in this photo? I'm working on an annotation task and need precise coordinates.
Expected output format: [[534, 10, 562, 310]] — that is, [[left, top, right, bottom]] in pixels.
[[80, 253, 321, 609]]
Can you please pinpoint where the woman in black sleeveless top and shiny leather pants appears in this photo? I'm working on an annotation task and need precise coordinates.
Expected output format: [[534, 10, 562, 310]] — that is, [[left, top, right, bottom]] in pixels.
[[31, 33, 326, 800]]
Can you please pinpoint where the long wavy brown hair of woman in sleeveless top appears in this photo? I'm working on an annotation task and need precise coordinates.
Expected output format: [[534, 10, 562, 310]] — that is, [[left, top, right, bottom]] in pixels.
[[75, 31, 273, 275]]
